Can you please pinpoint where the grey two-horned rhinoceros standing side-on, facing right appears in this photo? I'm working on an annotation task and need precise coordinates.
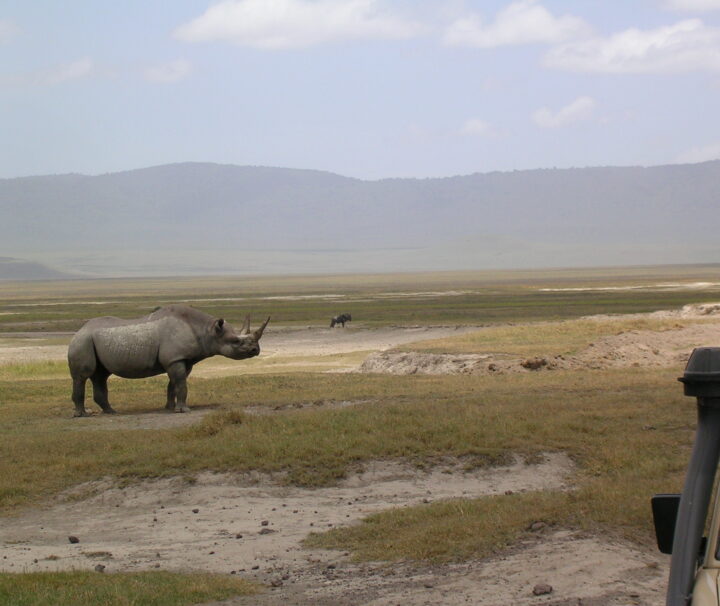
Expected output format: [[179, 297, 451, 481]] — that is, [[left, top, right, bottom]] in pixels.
[[68, 305, 270, 417]]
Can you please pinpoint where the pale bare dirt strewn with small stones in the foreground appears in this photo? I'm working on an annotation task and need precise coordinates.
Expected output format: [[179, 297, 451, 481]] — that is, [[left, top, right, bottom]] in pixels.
[[0, 453, 666, 606]]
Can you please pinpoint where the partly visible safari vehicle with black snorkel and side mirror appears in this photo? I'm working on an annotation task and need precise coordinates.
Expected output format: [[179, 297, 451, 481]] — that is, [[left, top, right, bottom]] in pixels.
[[652, 347, 720, 606]]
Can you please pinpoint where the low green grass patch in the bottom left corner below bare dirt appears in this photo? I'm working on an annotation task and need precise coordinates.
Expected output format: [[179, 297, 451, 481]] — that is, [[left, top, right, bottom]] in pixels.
[[0, 572, 259, 606]]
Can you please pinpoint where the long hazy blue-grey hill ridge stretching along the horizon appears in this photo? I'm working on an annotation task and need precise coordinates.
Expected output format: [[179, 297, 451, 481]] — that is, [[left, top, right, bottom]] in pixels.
[[0, 161, 720, 274]]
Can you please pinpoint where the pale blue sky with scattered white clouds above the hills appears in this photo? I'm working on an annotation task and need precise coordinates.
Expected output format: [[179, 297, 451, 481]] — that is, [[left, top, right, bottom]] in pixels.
[[0, 0, 720, 179]]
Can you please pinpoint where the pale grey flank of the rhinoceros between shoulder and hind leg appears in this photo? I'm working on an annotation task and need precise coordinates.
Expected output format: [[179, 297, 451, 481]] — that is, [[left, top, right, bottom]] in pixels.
[[93, 322, 165, 379]]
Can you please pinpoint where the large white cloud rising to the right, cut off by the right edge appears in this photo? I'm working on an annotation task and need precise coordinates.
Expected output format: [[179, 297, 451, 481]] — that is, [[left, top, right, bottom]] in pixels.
[[543, 19, 720, 74]]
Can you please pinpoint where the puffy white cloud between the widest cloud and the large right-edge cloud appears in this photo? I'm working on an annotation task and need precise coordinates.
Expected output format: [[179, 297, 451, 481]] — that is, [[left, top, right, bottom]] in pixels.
[[443, 0, 590, 48]]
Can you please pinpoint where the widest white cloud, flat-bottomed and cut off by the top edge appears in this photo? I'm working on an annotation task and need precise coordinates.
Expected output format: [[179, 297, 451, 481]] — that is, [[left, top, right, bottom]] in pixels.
[[173, 0, 423, 50]]
